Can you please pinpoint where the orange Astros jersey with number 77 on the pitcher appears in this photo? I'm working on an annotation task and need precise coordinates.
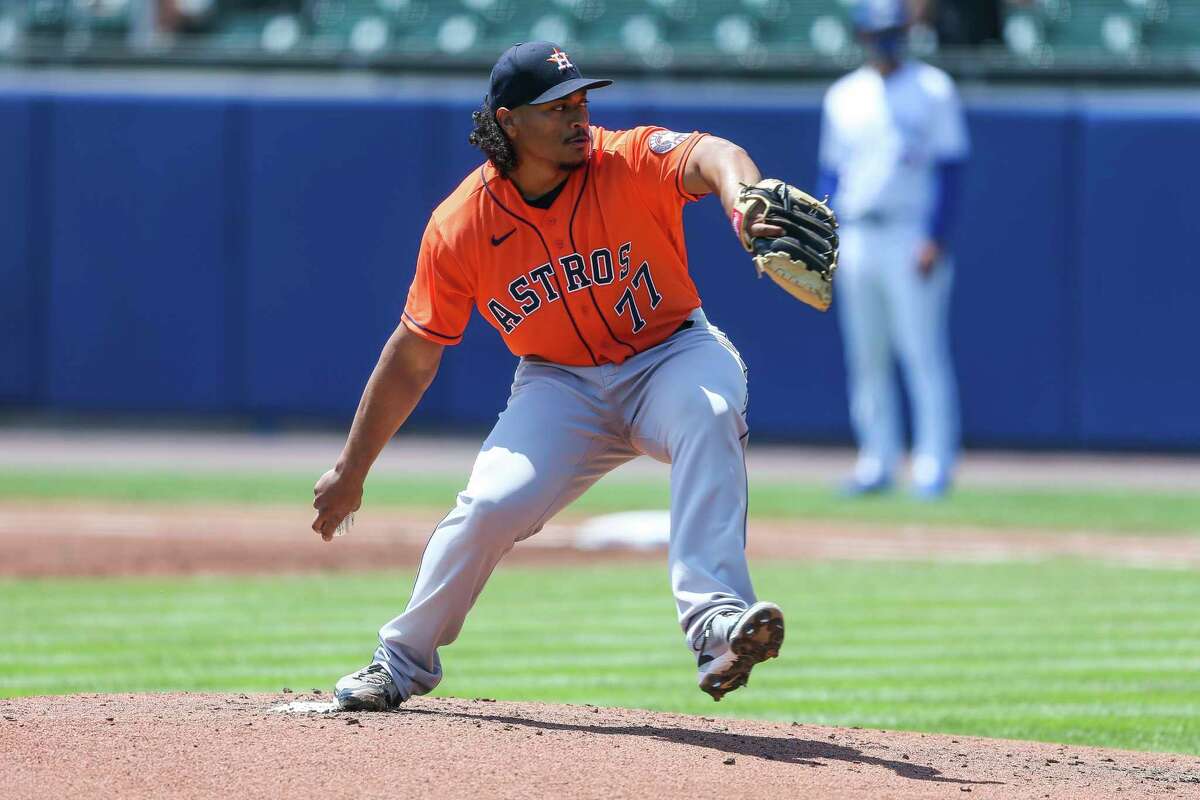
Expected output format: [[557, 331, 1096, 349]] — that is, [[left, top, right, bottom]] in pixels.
[[403, 126, 706, 366]]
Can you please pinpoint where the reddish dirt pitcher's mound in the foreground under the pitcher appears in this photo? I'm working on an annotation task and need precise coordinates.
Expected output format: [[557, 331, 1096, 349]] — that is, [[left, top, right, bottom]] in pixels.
[[0, 693, 1200, 800]]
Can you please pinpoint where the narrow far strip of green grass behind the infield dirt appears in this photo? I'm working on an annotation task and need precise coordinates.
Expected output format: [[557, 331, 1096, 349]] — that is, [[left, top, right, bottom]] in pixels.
[[0, 469, 1200, 534]]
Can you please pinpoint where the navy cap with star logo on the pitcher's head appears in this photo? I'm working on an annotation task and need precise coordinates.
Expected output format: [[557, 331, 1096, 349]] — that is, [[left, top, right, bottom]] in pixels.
[[487, 42, 612, 114]]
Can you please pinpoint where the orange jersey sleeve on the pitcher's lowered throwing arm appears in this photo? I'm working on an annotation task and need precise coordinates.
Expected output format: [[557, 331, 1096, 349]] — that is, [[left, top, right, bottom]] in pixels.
[[403, 213, 475, 344]]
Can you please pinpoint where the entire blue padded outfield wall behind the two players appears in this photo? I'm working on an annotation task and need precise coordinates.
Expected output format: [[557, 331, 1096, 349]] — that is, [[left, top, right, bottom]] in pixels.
[[0, 91, 1200, 447]]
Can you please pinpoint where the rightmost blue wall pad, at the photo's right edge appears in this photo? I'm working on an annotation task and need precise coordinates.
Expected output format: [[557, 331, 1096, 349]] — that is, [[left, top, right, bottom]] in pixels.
[[1079, 109, 1200, 446]]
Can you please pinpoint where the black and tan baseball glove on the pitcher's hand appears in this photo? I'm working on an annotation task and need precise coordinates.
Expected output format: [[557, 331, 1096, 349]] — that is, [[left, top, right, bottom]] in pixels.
[[733, 178, 838, 311]]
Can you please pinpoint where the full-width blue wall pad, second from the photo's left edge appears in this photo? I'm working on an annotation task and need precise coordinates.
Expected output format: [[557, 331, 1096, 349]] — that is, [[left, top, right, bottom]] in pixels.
[[46, 96, 236, 411]]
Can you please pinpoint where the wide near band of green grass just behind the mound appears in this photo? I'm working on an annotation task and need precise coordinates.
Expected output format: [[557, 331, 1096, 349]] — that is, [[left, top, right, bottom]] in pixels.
[[0, 561, 1200, 754]]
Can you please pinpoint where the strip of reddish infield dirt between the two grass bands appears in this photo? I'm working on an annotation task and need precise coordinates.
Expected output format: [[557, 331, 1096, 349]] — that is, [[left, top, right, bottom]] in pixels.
[[0, 501, 1200, 577]]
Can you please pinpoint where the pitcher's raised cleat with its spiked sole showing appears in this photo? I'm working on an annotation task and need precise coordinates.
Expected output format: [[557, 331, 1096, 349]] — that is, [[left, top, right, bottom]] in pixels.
[[696, 602, 784, 700]]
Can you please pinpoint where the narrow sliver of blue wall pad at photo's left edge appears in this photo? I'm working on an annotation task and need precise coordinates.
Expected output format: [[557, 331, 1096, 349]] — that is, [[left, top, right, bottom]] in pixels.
[[0, 95, 40, 404]]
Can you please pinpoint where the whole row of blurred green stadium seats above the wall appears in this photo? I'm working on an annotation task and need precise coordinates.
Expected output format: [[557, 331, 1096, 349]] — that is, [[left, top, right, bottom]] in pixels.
[[0, 0, 1200, 73]]
